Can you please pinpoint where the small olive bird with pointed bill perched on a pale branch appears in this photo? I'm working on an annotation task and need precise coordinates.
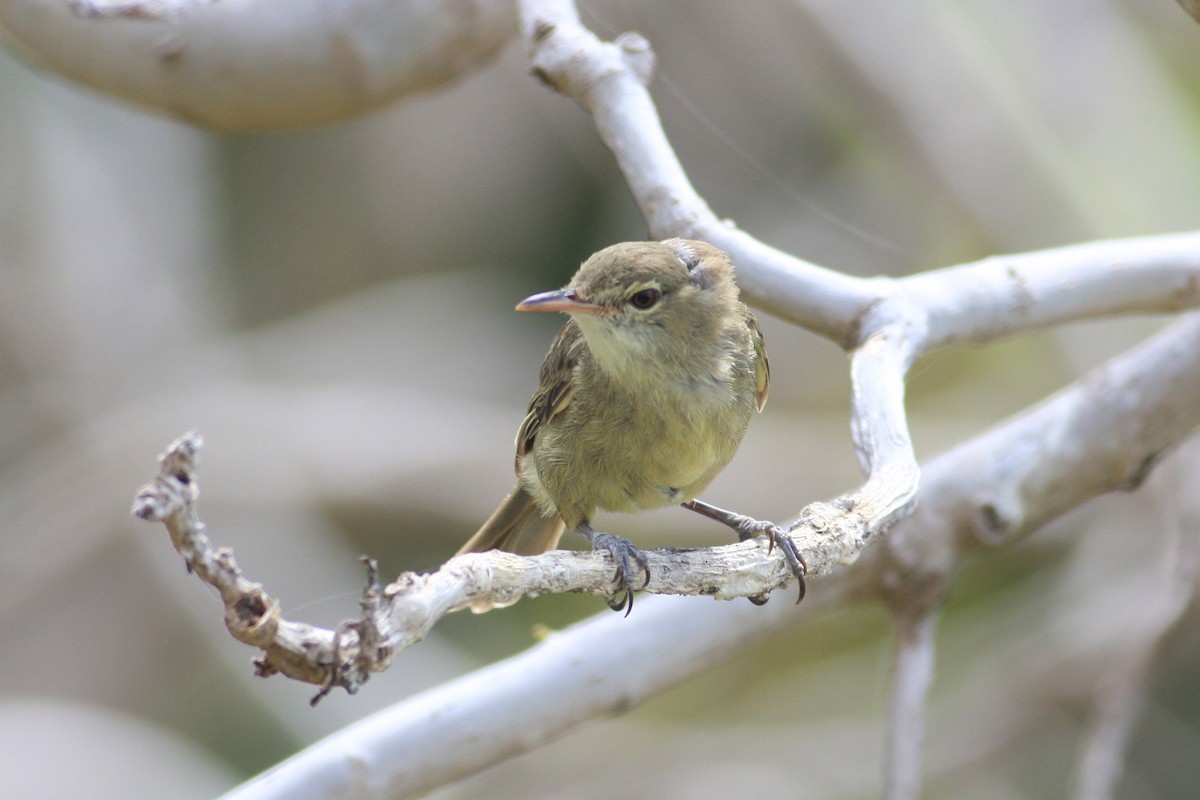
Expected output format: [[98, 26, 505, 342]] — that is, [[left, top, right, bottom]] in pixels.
[[458, 239, 805, 614]]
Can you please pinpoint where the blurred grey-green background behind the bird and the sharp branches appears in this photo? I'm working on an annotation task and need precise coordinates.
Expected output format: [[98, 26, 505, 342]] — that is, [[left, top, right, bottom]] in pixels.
[[0, 0, 1200, 800]]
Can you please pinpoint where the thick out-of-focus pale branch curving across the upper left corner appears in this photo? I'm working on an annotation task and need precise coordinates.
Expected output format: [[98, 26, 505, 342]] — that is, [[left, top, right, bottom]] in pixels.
[[0, 0, 515, 131]]
